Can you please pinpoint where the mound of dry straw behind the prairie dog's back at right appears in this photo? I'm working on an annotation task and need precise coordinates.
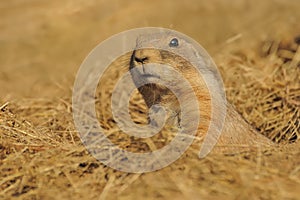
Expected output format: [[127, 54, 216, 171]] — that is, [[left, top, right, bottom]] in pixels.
[[220, 36, 300, 143]]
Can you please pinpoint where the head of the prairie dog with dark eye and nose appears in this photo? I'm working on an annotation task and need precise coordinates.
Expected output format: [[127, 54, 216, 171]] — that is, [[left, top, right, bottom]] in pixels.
[[130, 33, 216, 108]]
